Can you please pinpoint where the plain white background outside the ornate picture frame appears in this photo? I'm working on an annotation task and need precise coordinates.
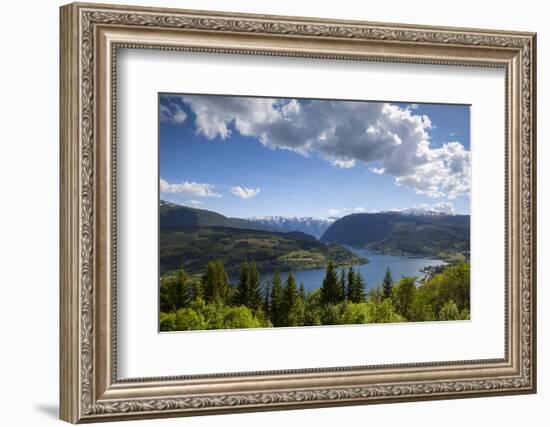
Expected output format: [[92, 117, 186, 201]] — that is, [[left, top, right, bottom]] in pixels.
[[0, 0, 550, 427]]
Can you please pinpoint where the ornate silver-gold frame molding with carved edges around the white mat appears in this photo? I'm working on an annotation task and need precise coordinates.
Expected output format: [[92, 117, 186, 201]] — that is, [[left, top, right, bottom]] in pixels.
[[60, 3, 536, 423]]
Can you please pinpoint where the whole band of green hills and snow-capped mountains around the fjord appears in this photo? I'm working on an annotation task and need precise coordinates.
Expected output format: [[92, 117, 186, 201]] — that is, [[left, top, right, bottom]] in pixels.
[[159, 201, 470, 274]]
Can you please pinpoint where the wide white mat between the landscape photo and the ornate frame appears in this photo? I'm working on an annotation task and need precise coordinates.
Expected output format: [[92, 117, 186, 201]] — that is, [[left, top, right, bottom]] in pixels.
[[117, 50, 504, 378]]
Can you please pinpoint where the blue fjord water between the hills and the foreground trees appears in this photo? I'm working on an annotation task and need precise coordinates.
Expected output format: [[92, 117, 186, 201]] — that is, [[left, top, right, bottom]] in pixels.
[[261, 246, 445, 292]]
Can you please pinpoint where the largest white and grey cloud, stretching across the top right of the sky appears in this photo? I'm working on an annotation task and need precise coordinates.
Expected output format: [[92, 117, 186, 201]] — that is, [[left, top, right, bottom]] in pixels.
[[175, 95, 470, 199]]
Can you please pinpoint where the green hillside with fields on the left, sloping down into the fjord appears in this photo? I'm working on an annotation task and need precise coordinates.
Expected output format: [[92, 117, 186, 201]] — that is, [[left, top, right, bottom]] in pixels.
[[159, 201, 368, 275]]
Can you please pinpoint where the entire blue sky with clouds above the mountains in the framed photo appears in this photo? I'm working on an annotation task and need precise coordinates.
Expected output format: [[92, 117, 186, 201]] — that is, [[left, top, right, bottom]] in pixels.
[[159, 94, 470, 218]]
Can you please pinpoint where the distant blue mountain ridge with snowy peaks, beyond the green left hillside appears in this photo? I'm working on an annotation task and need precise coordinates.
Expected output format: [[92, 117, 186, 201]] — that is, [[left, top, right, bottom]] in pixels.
[[160, 201, 470, 259]]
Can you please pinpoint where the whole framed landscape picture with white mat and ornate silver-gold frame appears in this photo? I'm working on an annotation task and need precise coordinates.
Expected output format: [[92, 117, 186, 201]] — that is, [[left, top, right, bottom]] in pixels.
[[60, 4, 536, 423]]
